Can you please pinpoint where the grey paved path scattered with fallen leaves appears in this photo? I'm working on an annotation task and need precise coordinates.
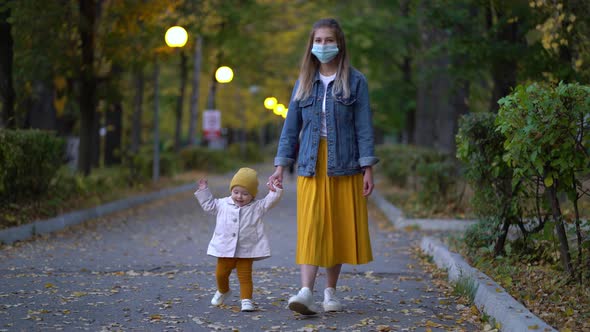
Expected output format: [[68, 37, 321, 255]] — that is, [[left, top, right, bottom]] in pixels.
[[0, 174, 481, 331]]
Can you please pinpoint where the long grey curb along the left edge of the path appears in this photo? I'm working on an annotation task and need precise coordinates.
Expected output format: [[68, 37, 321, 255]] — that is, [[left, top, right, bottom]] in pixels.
[[0, 183, 195, 244]]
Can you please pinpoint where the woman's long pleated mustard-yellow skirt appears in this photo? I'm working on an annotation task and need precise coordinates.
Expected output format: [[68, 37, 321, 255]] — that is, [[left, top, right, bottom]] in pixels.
[[295, 139, 373, 267]]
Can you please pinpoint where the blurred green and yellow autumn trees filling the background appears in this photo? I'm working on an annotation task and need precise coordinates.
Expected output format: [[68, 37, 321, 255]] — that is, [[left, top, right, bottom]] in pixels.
[[0, 0, 590, 174]]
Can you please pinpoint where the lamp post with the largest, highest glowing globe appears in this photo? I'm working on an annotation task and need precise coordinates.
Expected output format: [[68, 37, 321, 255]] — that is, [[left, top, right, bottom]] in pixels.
[[152, 26, 188, 182]]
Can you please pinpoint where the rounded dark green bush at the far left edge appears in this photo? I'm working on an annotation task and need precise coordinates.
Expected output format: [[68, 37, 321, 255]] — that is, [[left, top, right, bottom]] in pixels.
[[0, 130, 65, 202]]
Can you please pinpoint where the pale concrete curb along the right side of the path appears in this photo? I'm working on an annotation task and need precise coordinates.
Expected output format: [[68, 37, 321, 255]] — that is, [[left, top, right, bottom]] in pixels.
[[370, 191, 557, 332]]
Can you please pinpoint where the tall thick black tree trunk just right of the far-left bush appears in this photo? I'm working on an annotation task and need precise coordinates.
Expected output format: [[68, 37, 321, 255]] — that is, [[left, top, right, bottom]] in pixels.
[[78, 0, 98, 175]]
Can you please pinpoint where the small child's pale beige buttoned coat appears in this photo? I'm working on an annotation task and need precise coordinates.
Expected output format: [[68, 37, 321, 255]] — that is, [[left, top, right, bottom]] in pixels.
[[195, 188, 283, 259]]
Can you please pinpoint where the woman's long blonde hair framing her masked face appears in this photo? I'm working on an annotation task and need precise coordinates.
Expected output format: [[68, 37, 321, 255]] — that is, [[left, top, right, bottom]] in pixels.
[[294, 18, 350, 100]]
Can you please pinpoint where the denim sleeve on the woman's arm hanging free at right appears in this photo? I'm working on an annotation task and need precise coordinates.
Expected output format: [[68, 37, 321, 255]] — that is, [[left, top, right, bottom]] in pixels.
[[354, 75, 379, 167]]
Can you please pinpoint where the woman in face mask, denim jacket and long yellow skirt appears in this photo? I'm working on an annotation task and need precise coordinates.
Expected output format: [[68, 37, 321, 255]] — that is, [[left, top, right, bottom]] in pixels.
[[267, 19, 378, 315]]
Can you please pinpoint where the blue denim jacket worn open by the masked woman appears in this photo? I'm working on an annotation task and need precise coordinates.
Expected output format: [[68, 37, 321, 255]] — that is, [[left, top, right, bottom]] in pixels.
[[274, 68, 379, 176]]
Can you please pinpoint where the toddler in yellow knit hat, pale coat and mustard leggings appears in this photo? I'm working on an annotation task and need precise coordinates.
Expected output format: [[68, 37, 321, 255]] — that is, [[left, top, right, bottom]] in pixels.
[[195, 168, 282, 311]]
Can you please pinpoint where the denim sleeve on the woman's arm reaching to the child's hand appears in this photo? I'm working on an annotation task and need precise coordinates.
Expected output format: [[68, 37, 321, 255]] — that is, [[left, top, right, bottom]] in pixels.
[[274, 81, 301, 166]]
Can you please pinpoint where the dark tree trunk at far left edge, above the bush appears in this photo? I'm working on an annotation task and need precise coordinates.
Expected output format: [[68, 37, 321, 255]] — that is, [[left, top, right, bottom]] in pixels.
[[0, 2, 16, 128]]
